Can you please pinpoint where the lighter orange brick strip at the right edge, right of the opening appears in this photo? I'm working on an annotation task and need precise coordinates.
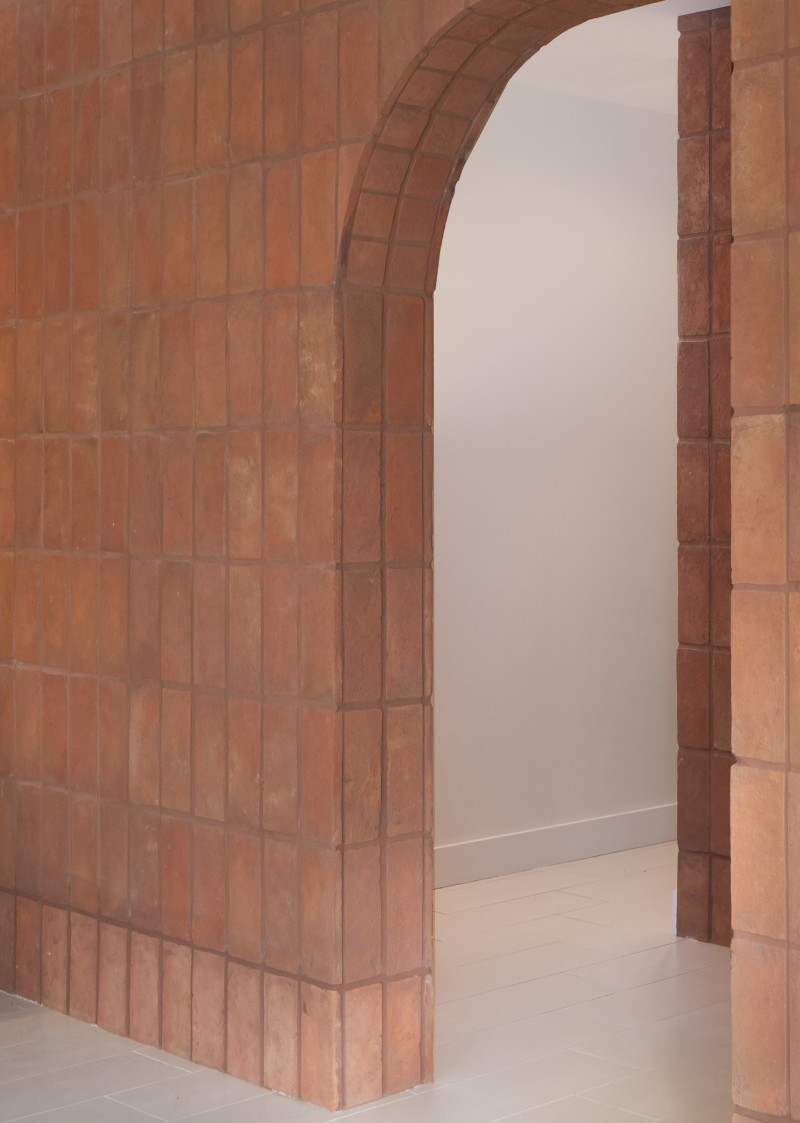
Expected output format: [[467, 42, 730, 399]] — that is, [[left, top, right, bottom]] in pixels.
[[731, 0, 800, 1120]]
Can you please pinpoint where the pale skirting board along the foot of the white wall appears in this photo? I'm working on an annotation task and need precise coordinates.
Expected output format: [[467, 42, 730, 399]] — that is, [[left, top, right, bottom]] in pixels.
[[434, 803, 678, 888]]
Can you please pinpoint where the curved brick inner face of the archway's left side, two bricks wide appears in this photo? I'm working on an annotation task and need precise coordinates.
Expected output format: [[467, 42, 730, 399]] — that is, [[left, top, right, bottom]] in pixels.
[[337, 0, 651, 1105]]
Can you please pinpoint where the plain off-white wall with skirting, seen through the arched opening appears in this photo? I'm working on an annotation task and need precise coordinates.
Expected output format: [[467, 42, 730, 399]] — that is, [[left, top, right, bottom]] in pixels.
[[435, 0, 728, 884]]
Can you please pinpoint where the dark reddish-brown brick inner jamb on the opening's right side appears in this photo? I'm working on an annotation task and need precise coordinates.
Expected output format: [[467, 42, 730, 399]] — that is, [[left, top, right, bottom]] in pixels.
[[678, 8, 733, 943]]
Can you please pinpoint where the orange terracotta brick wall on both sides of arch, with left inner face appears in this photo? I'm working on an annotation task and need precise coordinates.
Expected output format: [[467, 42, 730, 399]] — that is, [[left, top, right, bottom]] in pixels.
[[0, 0, 800, 1116]]
